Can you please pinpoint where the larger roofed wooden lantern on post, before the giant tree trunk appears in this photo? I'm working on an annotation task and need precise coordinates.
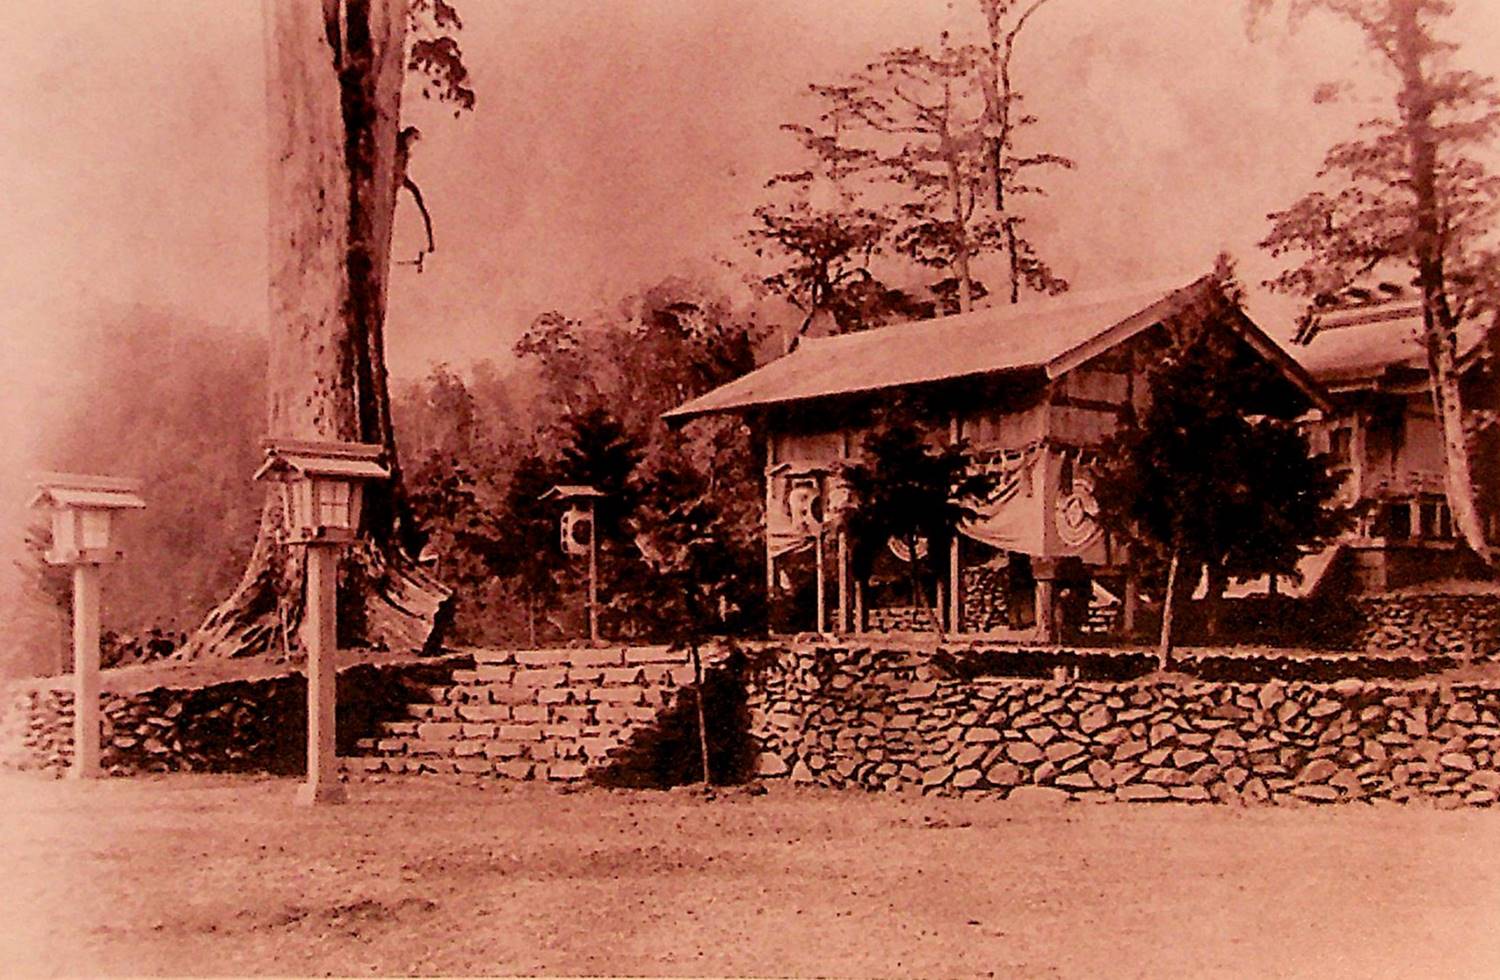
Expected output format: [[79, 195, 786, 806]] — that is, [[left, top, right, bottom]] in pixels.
[[255, 440, 390, 804]]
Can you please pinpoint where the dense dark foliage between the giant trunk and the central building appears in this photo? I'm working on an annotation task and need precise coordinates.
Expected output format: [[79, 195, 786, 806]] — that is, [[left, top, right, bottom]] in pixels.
[[396, 279, 765, 642]]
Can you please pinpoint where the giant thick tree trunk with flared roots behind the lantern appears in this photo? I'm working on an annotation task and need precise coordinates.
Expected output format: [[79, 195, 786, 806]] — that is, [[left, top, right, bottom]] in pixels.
[[183, 0, 450, 657]]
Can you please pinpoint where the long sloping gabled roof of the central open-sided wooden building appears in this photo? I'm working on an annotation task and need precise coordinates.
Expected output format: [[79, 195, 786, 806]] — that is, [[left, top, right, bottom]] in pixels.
[[663, 276, 1326, 422]]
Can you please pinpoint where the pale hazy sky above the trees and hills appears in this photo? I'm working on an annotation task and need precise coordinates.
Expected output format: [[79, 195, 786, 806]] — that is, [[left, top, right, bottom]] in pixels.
[[0, 0, 1500, 471]]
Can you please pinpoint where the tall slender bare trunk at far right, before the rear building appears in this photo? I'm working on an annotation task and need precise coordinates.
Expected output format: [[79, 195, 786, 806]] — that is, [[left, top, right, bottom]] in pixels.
[[1392, 0, 1493, 567]]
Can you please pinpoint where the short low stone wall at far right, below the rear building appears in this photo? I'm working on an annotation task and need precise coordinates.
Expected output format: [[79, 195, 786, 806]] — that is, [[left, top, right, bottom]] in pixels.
[[1355, 594, 1500, 659]]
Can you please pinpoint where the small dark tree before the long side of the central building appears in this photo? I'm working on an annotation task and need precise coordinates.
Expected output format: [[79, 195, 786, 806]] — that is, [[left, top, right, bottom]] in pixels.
[[843, 399, 998, 638]]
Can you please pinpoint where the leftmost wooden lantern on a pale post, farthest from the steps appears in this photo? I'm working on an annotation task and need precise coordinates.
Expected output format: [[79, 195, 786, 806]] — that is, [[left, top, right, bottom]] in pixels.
[[32, 473, 146, 779]]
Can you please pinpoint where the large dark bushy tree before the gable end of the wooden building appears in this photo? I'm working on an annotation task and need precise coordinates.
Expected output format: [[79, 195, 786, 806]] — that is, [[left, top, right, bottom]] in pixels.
[[1095, 279, 1344, 669]]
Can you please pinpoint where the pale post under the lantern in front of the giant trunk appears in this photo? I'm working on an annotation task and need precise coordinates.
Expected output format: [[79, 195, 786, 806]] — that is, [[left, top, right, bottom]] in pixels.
[[297, 545, 345, 806]]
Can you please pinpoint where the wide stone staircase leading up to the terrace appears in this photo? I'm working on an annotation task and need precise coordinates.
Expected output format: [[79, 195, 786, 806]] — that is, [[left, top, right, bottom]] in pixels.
[[342, 647, 711, 782]]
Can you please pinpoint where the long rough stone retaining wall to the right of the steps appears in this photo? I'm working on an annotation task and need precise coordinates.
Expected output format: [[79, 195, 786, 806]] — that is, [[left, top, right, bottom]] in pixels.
[[749, 647, 1500, 806]]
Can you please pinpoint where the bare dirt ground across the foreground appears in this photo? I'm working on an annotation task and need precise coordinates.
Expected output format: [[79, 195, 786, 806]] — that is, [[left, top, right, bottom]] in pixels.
[[0, 776, 1500, 977]]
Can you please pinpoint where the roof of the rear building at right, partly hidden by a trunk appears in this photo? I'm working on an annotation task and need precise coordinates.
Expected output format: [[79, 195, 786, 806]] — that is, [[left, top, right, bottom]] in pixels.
[[1292, 299, 1484, 387]]
